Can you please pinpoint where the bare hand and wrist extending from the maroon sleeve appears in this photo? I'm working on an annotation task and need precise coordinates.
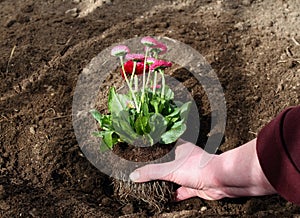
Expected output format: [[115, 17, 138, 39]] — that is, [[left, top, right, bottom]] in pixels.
[[130, 139, 276, 201]]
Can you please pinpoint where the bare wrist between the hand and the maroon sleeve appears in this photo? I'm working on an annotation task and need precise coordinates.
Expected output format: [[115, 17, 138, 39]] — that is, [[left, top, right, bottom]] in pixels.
[[210, 139, 276, 198]]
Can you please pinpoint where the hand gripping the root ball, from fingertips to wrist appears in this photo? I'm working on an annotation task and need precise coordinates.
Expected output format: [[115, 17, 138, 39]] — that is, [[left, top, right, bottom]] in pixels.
[[130, 140, 223, 201]]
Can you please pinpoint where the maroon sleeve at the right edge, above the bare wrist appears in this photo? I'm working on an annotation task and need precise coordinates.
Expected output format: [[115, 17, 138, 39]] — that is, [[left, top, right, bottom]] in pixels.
[[256, 106, 300, 205]]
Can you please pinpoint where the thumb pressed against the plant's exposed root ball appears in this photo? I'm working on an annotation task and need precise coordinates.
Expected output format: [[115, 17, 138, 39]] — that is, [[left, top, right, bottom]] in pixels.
[[129, 162, 174, 182]]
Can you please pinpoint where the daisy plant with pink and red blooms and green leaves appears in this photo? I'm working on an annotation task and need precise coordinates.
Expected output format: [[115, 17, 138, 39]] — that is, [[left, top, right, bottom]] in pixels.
[[90, 36, 191, 151]]
